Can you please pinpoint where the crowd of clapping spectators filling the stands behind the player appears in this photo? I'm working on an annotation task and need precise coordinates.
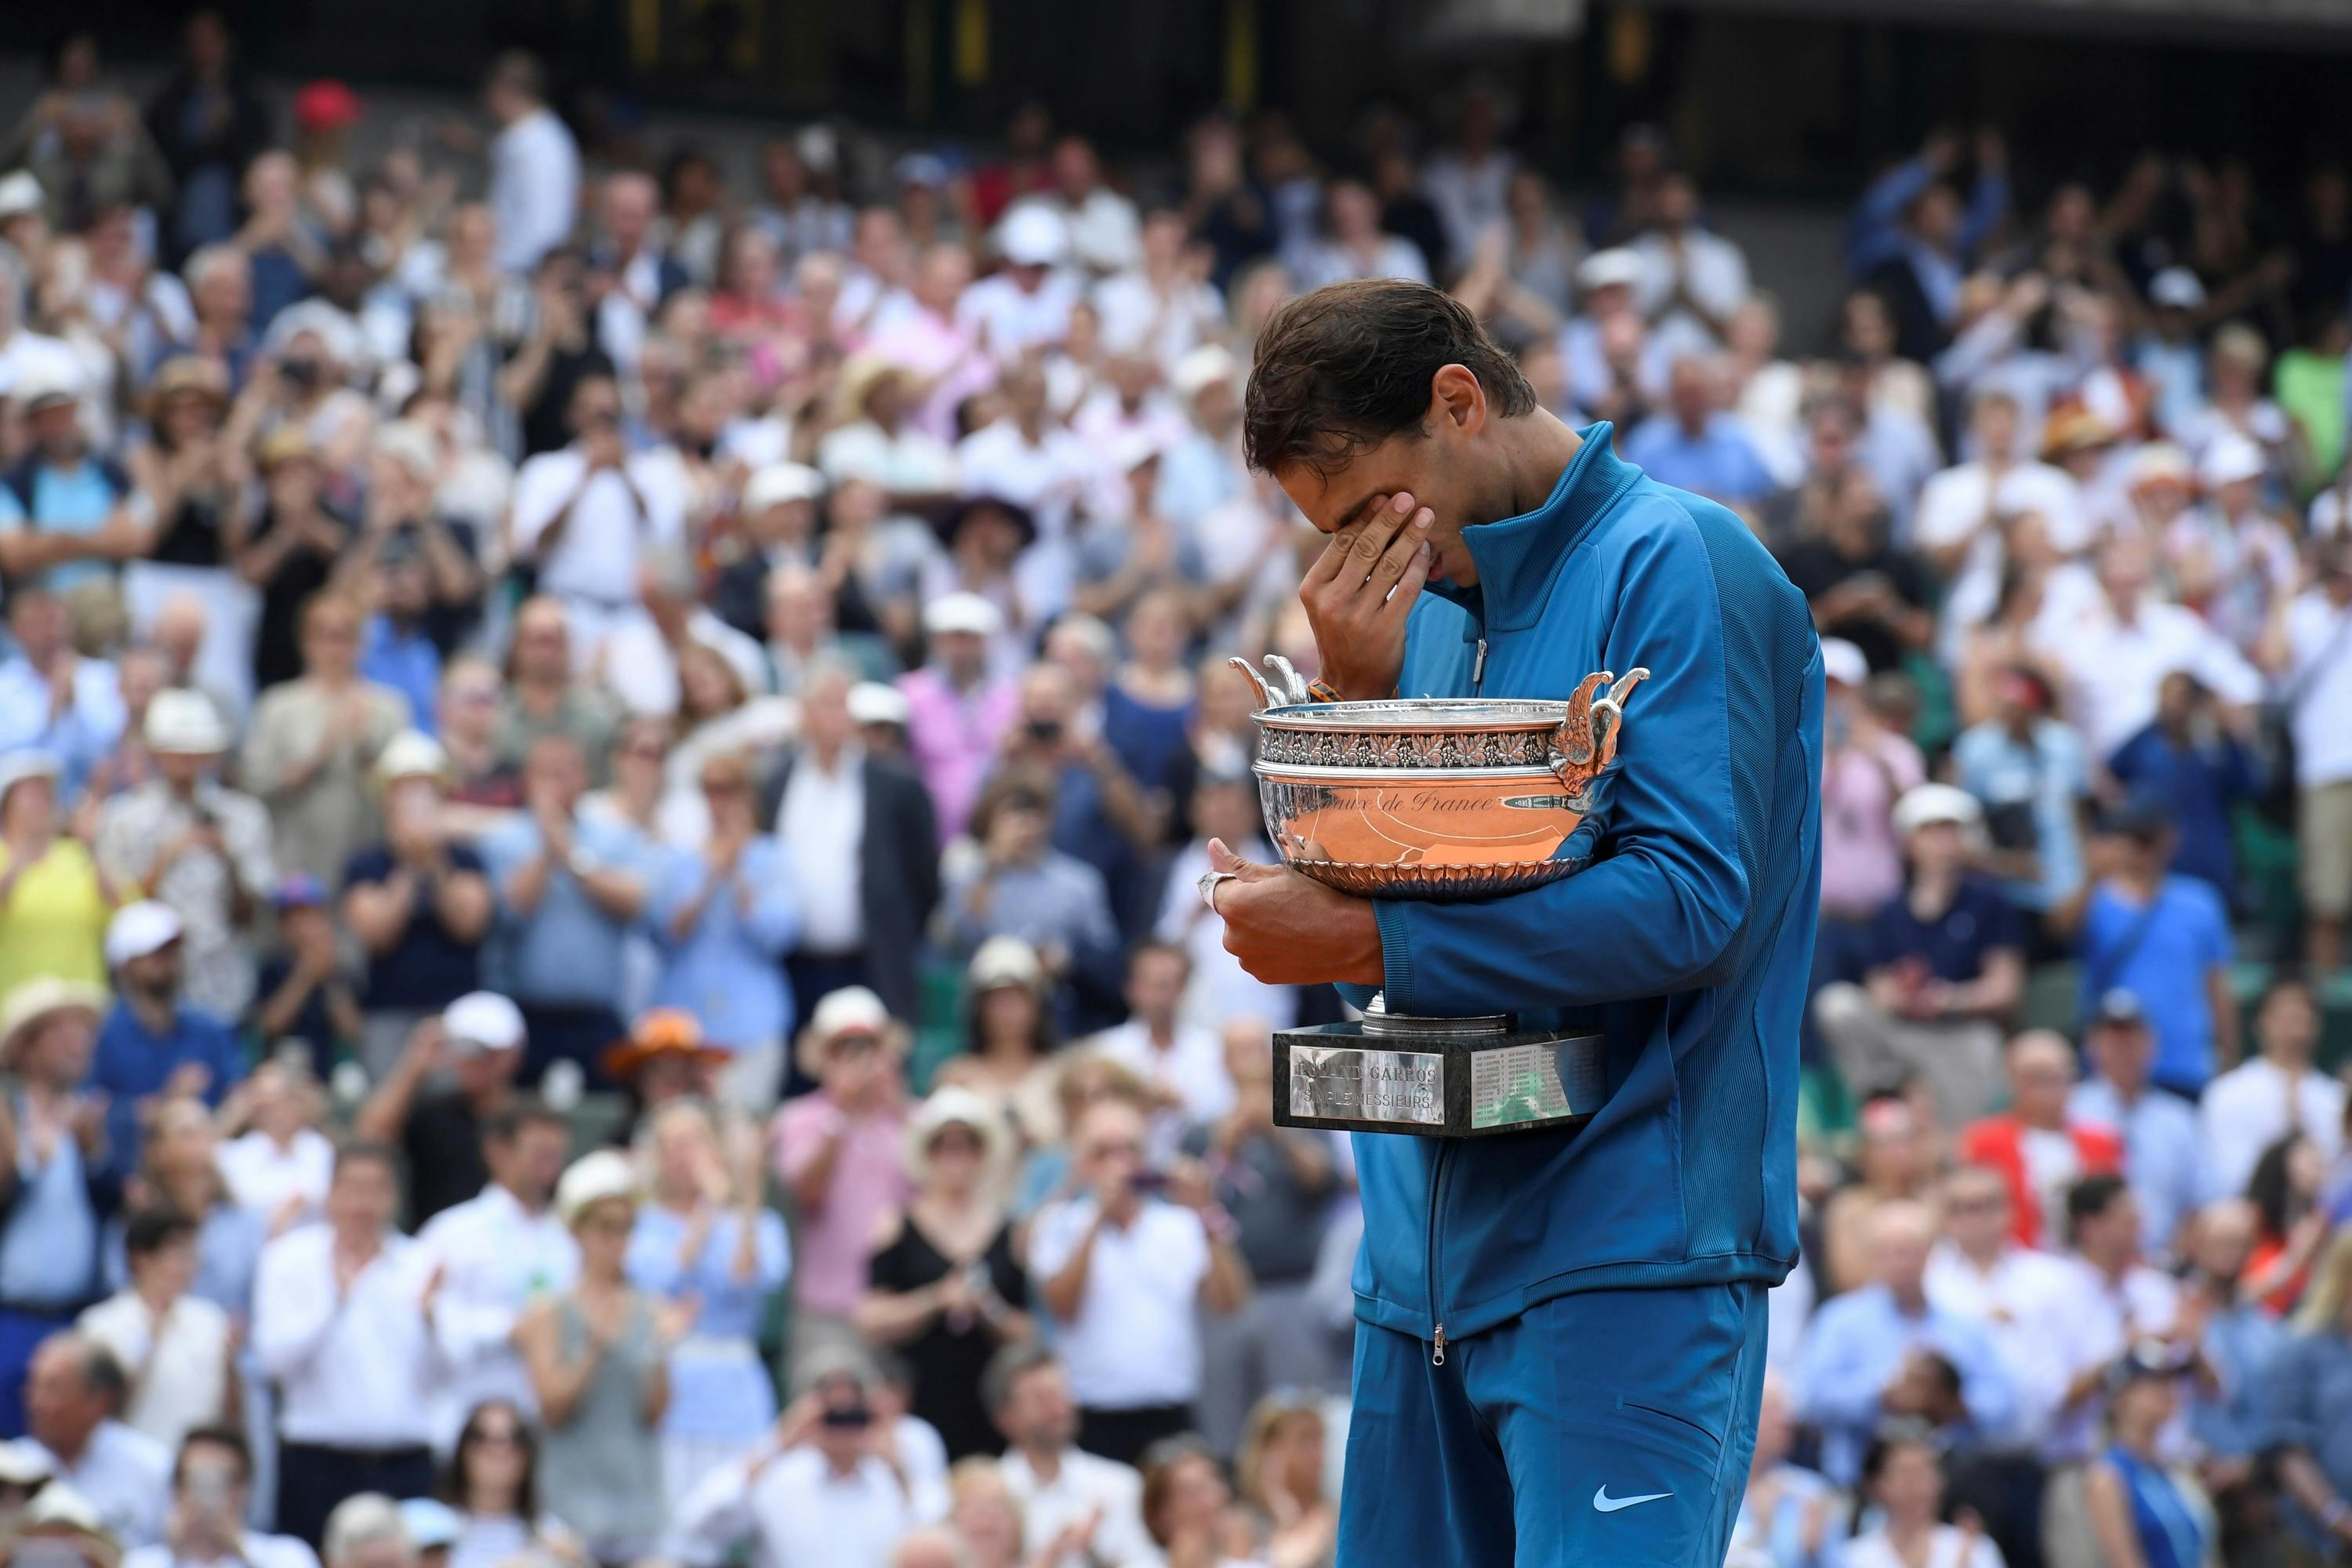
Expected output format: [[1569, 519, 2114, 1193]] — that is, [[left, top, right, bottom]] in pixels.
[[0, 16, 2352, 1568]]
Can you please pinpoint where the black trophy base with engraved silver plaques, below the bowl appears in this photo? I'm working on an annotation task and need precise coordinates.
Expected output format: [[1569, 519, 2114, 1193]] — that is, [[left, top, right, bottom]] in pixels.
[[1275, 996, 1604, 1138]]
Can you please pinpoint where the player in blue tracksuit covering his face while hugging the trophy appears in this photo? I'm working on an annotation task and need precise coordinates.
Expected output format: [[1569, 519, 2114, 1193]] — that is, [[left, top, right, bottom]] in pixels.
[[1209, 282, 1820, 1568]]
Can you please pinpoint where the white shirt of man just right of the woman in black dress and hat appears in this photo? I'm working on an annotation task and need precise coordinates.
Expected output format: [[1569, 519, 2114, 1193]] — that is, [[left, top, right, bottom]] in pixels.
[[1030, 1196, 1209, 1410]]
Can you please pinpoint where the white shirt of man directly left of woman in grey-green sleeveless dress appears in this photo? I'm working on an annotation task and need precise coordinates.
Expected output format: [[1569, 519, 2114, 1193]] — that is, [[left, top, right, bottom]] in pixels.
[[416, 1182, 581, 1450]]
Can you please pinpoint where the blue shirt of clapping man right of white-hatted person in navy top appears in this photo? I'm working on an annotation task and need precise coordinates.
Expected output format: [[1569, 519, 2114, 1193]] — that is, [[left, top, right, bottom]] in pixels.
[[480, 815, 654, 1008]]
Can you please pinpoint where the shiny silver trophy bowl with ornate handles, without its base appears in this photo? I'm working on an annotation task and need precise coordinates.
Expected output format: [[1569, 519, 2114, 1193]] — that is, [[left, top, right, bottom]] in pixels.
[[1232, 656, 1649, 900]]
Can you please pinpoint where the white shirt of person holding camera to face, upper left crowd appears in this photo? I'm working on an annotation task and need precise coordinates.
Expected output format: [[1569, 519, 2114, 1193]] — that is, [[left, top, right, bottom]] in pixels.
[[515, 447, 687, 609]]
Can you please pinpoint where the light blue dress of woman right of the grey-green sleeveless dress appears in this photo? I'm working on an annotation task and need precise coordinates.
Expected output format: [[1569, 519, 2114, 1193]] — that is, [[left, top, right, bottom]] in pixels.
[[628, 1203, 793, 1441]]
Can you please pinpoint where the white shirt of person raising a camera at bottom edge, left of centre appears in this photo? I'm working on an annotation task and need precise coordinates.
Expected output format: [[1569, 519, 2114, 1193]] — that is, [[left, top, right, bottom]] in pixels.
[[673, 1448, 922, 1568]]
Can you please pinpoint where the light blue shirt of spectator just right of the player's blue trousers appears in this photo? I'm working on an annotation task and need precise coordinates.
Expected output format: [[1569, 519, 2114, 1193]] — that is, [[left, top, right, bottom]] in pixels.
[[1797, 1286, 2016, 1486]]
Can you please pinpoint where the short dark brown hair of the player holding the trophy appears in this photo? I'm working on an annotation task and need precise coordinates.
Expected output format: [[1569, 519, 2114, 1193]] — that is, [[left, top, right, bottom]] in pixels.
[[1242, 278, 1536, 477]]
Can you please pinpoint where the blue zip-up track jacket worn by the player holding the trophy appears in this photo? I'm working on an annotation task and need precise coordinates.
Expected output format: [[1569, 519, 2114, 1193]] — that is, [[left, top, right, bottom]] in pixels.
[[1348, 423, 1820, 1340]]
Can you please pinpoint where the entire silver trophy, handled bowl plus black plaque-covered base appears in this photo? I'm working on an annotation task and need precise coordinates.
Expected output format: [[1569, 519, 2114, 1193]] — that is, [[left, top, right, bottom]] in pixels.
[[1204, 656, 1649, 1138]]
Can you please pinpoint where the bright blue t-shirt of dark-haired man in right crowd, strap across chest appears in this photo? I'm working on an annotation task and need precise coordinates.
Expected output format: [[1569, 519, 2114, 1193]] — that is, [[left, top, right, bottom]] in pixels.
[[2082, 877, 2230, 1093]]
